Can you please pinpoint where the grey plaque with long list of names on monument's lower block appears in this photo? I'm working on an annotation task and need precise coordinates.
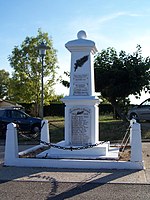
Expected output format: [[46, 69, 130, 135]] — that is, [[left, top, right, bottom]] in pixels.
[[70, 107, 91, 146]]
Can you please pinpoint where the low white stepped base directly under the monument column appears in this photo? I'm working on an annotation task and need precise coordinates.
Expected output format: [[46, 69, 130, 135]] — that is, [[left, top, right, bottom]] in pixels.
[[37, 141, 119, 160]]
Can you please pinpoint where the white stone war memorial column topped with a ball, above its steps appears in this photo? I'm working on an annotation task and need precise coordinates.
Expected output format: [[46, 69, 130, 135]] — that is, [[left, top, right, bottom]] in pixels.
[[62, 31, 99, 146]]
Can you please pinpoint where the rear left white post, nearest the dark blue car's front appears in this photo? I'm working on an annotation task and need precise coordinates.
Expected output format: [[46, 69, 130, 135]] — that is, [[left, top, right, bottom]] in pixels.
[[41, 120, 50, 144]]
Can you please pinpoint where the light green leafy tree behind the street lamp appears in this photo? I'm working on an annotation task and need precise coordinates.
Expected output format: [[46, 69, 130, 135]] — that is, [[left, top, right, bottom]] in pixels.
[[8, 29, 58, 115]]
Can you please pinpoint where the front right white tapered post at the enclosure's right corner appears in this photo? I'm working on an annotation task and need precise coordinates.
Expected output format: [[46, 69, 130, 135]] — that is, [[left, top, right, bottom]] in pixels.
[[131, 123, 142, 162]]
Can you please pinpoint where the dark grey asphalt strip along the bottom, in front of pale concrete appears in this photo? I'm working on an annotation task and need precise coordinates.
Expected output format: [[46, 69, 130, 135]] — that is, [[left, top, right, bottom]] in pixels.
[[0, 181, 150, 200]]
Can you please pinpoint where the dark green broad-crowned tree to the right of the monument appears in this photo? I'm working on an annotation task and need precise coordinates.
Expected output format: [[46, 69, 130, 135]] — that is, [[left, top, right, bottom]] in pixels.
[[94, 45, 150, 120]]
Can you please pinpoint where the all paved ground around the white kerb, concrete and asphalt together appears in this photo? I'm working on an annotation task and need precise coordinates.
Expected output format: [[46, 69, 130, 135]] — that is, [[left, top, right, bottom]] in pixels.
[[0, 143, 150, 200]]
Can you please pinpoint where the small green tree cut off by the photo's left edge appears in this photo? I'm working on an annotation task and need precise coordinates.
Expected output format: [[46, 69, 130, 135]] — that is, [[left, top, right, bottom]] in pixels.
[[0, 69, 10, 99]]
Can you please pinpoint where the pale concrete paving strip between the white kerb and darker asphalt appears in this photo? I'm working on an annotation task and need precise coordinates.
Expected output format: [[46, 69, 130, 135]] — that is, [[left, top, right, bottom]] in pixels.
[[0, 167, 149, 184]]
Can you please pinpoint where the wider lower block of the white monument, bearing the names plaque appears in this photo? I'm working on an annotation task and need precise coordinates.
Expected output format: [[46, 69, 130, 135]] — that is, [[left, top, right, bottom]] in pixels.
[[63, 97, 99, 146]]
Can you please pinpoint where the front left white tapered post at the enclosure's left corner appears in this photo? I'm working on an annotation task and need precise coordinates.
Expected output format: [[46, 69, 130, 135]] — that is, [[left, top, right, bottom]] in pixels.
[[4, 123, 19, 165]]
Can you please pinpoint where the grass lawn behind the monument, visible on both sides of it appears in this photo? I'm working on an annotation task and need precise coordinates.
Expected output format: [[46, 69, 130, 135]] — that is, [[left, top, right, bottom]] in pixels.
[[45, 115, 150, 143]]
